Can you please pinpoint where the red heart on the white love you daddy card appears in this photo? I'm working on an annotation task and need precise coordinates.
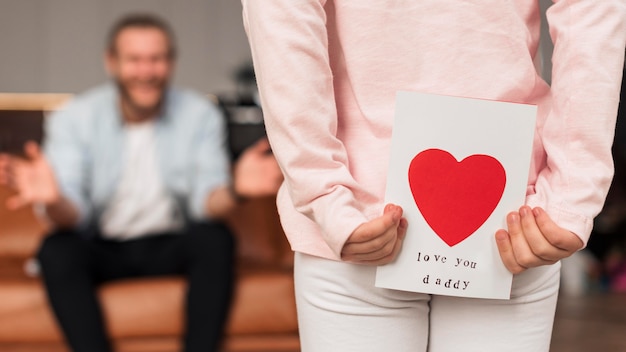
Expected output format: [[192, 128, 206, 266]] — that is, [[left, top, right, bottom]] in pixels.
[[409, 149, 506, 247]]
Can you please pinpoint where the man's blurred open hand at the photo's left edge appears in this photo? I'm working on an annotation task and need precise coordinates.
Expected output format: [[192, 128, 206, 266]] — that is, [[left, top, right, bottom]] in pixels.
[[0, 142, 61, 210]]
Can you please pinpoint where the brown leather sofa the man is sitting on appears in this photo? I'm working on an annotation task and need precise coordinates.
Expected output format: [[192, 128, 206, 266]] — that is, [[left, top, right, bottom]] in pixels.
[[0, 94, 299, 352]]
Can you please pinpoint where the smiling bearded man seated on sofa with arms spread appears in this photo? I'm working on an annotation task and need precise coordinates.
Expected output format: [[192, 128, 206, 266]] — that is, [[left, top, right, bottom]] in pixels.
[[0, 15, 282, 352]]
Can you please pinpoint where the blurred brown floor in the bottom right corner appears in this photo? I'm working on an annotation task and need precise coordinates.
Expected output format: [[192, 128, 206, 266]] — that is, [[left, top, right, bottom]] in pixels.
[[550, 293, 626, 352]]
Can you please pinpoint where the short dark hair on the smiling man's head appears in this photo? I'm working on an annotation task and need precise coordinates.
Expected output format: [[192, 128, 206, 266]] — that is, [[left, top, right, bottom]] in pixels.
[[107, 13, 176, 59]]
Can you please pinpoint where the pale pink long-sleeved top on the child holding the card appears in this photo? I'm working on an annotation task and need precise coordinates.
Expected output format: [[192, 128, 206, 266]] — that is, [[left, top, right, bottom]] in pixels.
[[242, 0, 626, 260]]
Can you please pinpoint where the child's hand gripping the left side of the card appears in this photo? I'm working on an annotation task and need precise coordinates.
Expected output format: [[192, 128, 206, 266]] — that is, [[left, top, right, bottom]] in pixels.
[[341, 204, 408, 265]]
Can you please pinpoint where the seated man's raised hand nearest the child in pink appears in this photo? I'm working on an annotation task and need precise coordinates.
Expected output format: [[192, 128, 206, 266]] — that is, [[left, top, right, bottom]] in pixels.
[[233, 138, 283, 197]]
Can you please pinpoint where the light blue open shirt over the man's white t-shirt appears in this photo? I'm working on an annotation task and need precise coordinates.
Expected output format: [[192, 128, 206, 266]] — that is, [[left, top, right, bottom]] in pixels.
[[44, 83, 230, 231]]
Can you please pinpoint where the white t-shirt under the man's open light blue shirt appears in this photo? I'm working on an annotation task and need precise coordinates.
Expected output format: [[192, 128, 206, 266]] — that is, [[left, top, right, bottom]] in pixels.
[[100, 121, 183, 240]]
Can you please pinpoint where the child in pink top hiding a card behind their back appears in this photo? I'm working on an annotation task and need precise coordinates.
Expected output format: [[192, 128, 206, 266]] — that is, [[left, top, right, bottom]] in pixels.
[[242, 0, 626, 352]]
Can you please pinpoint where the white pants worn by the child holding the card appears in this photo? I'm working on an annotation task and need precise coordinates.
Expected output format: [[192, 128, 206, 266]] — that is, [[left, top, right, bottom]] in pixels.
[[295, 253, 560, 352]]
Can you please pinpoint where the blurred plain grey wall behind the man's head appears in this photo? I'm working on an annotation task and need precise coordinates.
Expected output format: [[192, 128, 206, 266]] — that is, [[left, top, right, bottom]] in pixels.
[[0, 0, 251, 94]]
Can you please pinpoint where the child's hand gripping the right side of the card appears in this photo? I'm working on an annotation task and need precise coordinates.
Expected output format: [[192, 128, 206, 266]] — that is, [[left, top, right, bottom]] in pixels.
[[496, 206, 584, 274]]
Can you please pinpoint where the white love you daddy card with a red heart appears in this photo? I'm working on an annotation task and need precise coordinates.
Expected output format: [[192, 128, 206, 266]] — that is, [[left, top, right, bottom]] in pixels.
[[376, 91, 536, 299]]
